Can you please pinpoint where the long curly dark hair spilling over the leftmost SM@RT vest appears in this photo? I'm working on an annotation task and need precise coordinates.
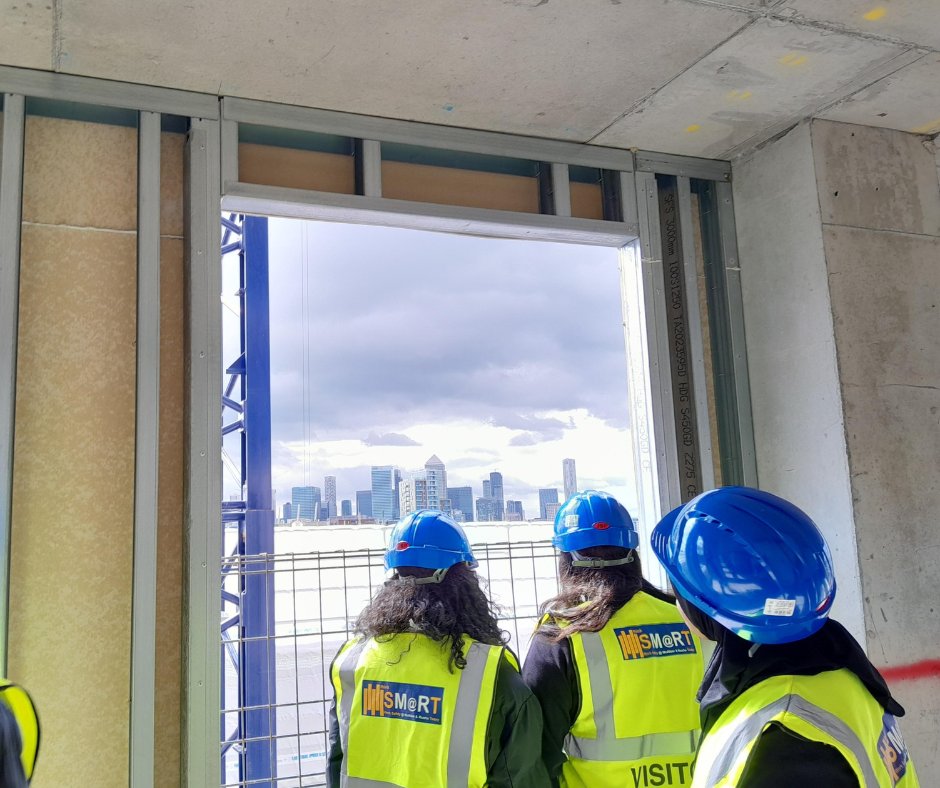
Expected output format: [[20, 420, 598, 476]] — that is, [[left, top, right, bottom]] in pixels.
[[354, 564, 509, 671]]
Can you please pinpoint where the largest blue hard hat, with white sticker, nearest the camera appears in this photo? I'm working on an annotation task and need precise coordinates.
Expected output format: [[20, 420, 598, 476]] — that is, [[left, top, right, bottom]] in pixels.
[[652, 487, 836, 643]]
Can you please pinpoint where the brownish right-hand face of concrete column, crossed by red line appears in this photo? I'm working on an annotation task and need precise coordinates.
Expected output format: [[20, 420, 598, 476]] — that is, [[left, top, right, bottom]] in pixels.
[[812, 122, 940, 772]]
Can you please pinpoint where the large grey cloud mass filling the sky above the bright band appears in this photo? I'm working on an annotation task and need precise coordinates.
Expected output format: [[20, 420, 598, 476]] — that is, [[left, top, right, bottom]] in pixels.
[[271, 220, 627, 439]]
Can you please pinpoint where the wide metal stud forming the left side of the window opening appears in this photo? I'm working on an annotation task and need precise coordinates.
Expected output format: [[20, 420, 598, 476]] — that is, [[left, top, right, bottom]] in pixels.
[[185, 119, 222, 786]]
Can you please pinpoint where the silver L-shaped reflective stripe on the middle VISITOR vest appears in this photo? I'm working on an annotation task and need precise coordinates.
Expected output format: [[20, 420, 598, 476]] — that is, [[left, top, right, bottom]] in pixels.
[[565, 632, 698, 761]]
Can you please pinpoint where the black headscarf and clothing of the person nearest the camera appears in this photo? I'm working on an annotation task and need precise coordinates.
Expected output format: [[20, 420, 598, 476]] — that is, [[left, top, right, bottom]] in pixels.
[[681, 600, 904, 788]]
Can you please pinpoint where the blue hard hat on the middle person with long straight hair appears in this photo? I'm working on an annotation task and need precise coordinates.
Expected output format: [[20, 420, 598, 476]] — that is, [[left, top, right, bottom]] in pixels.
[[552, 490, 640, 553]]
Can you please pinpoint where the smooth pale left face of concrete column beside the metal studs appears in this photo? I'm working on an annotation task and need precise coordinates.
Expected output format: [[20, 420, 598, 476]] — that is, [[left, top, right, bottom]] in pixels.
[[734, 124, 865, 643]]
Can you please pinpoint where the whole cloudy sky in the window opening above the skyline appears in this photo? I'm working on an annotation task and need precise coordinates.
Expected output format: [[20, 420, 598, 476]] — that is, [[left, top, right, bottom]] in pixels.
[[225, 219, 634, 518]]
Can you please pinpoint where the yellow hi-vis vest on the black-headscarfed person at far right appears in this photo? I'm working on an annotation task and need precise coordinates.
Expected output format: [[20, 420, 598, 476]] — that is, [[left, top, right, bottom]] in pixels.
[[693, 670, 919, 788]]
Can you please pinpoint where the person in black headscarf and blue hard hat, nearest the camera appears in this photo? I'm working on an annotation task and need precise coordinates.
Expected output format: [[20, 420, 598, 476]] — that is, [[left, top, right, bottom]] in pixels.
[[652, 487, 918, 788]]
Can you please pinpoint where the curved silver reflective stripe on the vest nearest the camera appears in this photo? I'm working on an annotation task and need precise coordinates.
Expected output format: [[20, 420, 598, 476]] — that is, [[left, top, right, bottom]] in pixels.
[[704, 695, 878, 788]]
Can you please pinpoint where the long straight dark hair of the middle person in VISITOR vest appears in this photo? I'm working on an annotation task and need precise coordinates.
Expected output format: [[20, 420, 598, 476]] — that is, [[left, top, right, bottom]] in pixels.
[[538, 545, 675, 643]]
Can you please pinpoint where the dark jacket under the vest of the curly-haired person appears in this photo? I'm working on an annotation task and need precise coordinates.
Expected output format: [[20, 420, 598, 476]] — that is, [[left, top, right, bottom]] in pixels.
[[326, 644, 549, 788]]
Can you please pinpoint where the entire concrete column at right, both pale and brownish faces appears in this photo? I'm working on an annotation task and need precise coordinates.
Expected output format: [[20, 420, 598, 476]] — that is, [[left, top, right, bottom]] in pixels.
[[734, 121, 940, 783]]
